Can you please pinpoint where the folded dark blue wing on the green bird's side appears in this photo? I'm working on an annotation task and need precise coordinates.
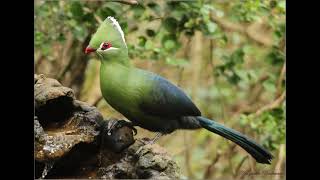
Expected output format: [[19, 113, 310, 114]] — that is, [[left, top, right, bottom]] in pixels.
[[140, 75, 201, 117]]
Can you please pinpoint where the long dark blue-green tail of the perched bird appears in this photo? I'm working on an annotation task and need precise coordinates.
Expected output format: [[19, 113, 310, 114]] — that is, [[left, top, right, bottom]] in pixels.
[[197, 117, 273, 164]]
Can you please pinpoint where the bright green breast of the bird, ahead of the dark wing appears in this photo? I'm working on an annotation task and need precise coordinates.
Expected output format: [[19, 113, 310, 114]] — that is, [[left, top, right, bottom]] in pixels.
[[100, 63, 152, 118]]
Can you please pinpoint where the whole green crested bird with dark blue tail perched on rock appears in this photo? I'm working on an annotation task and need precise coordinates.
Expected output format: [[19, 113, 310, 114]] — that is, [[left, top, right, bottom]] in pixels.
[[85, 17, 273, 164]]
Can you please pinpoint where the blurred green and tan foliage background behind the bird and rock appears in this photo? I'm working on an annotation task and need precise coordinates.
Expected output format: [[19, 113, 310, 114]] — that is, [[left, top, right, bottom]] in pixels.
[[34, 0, 286, 179]]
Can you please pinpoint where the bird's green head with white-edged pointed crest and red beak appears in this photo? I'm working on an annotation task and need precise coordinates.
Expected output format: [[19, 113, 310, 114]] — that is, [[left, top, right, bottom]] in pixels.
[[85, 16, 128, 60]]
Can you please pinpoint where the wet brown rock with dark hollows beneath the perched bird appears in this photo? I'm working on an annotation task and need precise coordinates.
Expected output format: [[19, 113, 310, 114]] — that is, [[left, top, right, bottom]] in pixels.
[[34, 75, 179, 179]]
